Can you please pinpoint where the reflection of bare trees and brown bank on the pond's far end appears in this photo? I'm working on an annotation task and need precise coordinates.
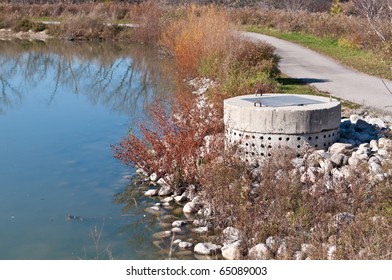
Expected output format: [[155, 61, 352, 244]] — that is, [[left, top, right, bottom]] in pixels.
[[0, 40, 174, 114]]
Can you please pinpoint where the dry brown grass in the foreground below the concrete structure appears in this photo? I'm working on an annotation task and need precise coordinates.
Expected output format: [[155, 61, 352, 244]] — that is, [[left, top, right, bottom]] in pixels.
[[201, 147, 392, 259]]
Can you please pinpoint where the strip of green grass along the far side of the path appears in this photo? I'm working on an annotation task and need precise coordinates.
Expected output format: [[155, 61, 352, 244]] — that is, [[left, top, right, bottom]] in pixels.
[[245, 26, 392, 79]]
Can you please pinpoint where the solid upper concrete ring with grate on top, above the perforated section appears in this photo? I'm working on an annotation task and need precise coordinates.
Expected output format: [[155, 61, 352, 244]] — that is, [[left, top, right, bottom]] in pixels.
[[224, 94, 341, 134]]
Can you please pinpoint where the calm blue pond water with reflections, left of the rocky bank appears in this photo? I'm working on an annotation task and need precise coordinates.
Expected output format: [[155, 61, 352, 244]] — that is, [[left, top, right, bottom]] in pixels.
[[0, 38, 182, 260]]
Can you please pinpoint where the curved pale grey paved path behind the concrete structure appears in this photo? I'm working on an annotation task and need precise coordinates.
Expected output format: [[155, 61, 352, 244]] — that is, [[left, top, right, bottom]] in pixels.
[[242, 32, 392, 112]]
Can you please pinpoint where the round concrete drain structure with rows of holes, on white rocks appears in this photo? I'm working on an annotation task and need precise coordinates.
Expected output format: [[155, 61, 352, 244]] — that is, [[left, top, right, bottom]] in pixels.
[[224, 94, 341, 159]]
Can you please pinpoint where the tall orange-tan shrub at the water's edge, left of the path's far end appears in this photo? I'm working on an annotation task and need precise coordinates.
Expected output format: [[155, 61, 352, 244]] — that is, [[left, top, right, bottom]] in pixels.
[[162, 6, 235, 76]]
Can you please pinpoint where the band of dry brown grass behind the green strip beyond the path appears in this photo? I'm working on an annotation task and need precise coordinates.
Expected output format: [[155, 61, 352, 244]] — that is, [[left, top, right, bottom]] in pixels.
[[232, 9, 392, 58]]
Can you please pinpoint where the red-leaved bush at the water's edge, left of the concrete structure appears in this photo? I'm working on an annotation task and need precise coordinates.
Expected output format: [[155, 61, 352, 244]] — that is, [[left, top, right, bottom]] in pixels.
[[114, 91, 223, 187]]
